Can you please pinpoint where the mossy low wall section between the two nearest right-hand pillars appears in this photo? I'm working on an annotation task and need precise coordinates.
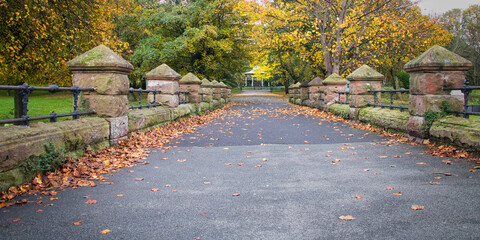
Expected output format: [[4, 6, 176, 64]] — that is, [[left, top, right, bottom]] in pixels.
[[358, 107, 410, 132]]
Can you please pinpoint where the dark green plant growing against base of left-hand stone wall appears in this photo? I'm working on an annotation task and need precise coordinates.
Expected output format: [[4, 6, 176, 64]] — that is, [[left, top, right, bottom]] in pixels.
[[23, 143, 65, 176]]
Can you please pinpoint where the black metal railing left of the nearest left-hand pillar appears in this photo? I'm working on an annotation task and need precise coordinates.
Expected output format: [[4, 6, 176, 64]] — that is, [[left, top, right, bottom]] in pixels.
[[0, 83, 95, 127]]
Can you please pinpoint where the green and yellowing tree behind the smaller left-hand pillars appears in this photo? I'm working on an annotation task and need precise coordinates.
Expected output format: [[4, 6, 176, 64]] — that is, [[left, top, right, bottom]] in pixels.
[[121, 0, 252, 86]]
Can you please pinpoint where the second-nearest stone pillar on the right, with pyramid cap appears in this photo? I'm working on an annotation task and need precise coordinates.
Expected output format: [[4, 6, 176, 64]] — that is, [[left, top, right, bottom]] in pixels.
[[347, 65, 385, 120]]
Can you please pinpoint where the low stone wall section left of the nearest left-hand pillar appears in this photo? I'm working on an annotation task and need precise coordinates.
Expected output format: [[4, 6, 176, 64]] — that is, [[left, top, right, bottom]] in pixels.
[[0, 117, 110, 191]]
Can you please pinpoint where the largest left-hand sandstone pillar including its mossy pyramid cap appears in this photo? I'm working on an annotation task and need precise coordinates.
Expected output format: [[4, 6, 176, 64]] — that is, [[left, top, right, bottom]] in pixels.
[[67, 45, 133, 144]]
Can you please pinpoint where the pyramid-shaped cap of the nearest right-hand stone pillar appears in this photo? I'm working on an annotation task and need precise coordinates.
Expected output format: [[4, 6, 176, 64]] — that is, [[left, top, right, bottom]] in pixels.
[[404, 45, 473, 72]]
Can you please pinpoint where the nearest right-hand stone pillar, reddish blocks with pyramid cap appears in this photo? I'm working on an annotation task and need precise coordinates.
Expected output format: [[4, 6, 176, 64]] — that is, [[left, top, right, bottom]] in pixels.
[[405, 45, 472, 142]]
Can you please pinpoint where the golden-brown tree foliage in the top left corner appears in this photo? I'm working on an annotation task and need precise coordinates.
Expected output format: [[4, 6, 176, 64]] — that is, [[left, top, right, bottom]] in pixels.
[[0, 0, 128, 85]]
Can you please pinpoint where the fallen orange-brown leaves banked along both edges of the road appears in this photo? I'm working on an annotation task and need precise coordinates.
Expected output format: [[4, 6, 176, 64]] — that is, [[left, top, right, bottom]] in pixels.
[[0, 103, 480, 210]]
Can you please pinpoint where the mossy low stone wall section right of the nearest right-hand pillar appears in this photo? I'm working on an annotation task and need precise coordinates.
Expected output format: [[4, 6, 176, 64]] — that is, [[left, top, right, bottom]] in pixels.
[[430, 116, 480, 151]]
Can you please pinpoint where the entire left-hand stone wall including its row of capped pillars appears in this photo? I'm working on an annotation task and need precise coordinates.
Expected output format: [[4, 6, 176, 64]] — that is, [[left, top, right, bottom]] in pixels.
[[0, 45, 229, 191]]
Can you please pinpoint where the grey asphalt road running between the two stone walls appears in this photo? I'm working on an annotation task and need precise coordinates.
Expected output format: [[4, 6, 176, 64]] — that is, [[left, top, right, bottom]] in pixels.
[[0, 92, 480, 239]]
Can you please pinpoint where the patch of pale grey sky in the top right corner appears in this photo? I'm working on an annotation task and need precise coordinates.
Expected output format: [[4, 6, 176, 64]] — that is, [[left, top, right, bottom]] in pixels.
[[418, 0, 480, 15]]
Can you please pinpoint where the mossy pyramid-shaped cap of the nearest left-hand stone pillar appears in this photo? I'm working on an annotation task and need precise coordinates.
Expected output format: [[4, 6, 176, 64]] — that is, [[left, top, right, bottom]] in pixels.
[[67, 44, 133, 74]]
